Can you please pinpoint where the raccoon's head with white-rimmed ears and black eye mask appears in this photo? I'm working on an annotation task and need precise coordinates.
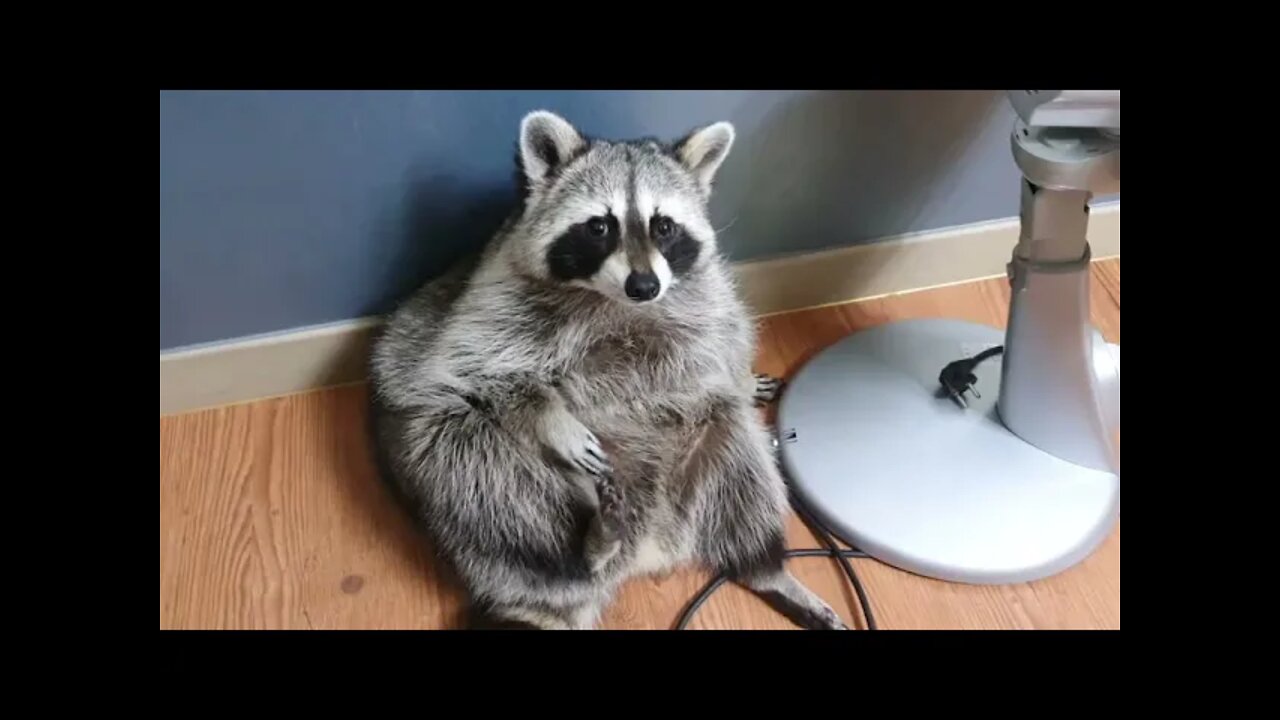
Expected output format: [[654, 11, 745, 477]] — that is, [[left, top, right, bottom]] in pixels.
[[506, 111, 733, 304]]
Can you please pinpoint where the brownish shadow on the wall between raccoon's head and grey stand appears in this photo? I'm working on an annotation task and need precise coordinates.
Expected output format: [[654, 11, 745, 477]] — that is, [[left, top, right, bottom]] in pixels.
[[716, 91, 1018, 267]]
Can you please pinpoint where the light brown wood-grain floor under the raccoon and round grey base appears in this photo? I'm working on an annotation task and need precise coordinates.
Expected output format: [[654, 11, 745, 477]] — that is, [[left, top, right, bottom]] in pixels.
[[160, 260, 1120, 629]]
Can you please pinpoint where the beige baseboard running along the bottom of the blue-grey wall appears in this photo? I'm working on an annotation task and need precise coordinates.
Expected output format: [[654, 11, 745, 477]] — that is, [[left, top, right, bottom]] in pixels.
[[160, 202, 1120, 415]]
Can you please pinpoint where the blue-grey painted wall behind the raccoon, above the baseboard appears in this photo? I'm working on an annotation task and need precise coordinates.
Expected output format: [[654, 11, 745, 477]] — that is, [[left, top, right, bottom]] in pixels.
[[160, 91, 1121, 350]]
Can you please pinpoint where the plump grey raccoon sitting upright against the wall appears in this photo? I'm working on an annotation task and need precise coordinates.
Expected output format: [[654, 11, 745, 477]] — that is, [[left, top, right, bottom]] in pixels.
[[370, 110, 845, 629]]
